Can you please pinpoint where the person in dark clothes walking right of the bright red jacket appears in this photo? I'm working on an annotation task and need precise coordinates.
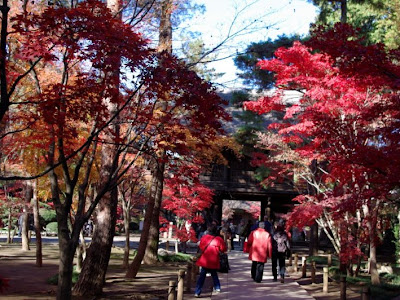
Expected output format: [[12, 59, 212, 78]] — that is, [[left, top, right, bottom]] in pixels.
[[272, 225, 290, 283]]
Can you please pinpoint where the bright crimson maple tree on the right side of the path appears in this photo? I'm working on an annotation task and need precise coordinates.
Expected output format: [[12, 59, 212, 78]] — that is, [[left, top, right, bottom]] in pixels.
[[245, 24, 400, 268]]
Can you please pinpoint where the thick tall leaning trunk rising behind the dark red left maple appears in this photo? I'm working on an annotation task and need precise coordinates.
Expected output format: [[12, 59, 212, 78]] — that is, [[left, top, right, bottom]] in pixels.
[[74, 0, 122, 296]]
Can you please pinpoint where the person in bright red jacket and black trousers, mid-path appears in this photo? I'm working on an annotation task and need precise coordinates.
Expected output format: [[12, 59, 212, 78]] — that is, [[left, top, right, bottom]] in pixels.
[[247, 222, 272, 282]]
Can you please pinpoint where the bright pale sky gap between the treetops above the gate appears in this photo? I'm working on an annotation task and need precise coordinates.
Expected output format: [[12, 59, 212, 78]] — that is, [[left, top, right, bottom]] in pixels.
[[190, 0, 317, 88]]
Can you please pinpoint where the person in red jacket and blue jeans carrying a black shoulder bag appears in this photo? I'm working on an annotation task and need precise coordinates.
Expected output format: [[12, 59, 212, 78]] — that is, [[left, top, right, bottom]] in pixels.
[[194, 224, 227, 298]]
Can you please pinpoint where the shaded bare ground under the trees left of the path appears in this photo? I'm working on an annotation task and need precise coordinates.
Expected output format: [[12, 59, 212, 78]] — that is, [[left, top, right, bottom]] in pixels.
[[0, 244, 191, 300]]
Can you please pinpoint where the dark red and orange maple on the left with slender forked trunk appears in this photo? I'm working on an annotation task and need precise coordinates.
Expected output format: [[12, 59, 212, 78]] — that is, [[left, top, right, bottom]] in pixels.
[[0, 0, 233, 299]]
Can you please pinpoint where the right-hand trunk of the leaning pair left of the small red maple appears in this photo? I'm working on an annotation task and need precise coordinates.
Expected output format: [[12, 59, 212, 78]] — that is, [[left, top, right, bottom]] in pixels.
[[143, 162, 165, 264]]
